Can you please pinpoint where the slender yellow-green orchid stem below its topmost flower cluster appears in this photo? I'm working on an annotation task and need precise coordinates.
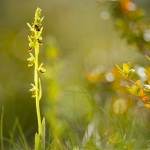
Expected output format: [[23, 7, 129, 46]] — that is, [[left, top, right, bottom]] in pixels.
[[34, 41, 42, 135]]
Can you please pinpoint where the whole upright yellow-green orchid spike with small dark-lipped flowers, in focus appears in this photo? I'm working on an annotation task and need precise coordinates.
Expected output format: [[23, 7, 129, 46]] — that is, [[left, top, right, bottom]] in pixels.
[[27, 8, 46, 150]]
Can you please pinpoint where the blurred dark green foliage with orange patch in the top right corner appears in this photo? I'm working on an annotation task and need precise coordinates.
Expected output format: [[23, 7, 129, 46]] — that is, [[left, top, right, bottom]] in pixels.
[[99, 0, 150, 55]]
